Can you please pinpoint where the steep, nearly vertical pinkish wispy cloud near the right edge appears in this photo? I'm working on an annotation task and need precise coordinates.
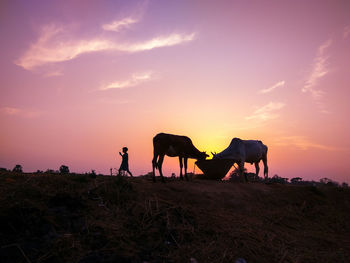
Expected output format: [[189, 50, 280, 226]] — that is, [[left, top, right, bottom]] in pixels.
[[302, 39, 332, 112]]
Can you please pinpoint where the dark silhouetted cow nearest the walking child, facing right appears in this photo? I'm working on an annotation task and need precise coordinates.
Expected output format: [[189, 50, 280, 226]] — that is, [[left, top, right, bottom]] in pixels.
[[152, 133, 209, 182]]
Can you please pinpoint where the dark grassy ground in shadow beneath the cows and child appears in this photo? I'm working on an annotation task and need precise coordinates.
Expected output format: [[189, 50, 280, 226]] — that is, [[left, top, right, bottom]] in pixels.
[[0, 172, 350, 263]]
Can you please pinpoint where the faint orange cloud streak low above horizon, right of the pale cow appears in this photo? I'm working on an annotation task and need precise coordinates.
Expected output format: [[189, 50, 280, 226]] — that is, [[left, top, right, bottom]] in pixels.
[[273, 136, 347, 151]]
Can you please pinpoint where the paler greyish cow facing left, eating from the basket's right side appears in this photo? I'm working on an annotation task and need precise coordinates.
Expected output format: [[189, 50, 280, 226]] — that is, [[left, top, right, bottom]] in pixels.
[[212, 138, 268, 181]]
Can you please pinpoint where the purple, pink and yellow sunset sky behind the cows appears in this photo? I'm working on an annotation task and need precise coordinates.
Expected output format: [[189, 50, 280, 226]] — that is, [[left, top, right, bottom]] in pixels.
[[0, 0, 350, 182]]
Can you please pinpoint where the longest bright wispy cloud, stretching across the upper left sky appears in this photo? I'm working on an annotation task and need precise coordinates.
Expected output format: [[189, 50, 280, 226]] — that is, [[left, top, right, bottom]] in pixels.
[[15, 25, 195, 70]]
